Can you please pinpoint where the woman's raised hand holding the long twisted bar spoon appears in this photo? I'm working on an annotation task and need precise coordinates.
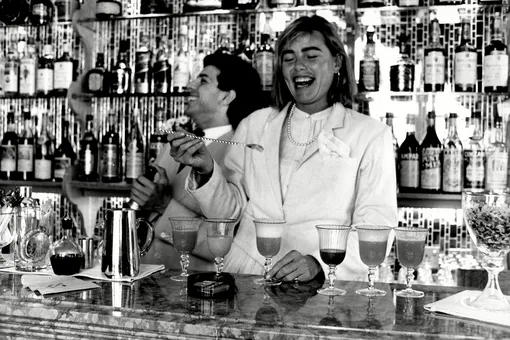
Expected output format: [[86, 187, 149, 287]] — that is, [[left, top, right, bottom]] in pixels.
[[167, 127, 214, 175]]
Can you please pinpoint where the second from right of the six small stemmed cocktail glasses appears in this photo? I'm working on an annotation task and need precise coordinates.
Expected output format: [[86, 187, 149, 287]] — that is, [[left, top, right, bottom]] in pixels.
[[356, 225, 391, 296]]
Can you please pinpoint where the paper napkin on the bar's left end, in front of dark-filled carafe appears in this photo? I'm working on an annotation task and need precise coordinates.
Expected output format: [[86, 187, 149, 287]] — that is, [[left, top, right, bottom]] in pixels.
[[21, 275, 99, 296]]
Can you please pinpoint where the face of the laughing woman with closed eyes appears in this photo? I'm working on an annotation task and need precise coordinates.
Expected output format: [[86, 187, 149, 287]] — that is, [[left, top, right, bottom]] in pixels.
[[282, 31, 340, 114]]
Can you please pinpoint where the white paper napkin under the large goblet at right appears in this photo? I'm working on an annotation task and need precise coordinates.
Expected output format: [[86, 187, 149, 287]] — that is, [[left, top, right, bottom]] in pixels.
[[424, 290, 510, 326]]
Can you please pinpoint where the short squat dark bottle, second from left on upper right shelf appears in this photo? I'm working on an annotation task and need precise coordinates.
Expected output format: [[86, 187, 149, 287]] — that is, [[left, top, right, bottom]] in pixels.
[[390, 34, 414, 92]]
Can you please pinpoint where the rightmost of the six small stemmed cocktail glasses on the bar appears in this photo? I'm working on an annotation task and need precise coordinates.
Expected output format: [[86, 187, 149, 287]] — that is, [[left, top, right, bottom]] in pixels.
[[395, 227, 428, 298]]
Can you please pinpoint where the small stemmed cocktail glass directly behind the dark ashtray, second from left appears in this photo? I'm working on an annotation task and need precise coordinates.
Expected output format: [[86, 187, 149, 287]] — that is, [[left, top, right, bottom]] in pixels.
[[204, 218, 236, 277]]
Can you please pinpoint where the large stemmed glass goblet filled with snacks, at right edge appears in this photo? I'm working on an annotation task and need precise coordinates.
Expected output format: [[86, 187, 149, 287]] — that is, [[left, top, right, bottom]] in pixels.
[[462, 191, 510, 312]]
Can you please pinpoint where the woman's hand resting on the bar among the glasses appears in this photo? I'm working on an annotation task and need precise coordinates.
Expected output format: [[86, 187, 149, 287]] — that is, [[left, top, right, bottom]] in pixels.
[[267, 250, 322, 282]]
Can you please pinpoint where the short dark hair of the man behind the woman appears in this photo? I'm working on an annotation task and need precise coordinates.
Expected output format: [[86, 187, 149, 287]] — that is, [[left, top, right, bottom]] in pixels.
[[204, 53, 263, 129]]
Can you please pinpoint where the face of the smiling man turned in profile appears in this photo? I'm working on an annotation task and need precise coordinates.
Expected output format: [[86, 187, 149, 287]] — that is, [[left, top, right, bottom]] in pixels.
[[185, 66, 225, 127]]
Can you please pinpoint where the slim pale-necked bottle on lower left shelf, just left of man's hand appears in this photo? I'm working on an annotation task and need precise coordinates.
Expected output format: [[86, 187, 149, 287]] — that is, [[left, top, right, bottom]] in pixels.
[[125, 108, 145, 183]]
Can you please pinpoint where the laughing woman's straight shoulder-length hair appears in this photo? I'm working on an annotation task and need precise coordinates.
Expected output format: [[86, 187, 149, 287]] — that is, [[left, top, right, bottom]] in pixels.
[[272, 15, 356, 110]]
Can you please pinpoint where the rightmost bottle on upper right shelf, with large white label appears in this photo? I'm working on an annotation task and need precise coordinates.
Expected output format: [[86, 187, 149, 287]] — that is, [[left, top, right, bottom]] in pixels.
[[483, 12, 508, 92]]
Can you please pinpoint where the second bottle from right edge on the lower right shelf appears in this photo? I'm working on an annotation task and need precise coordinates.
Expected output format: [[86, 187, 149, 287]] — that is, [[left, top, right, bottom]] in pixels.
[[463, 111, 485, 190]]
